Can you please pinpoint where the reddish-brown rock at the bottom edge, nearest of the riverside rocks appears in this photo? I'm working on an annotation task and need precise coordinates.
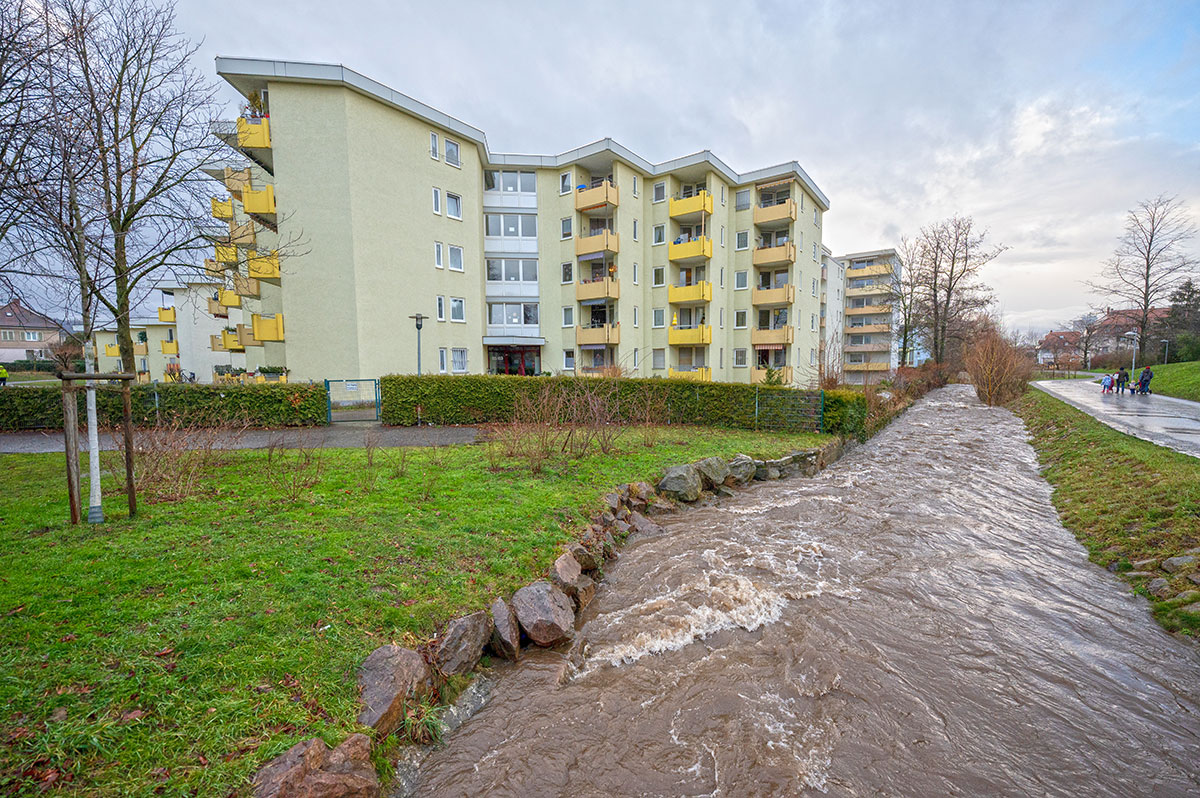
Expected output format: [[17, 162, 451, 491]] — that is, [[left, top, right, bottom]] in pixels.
[[254, 734, 380, 798]]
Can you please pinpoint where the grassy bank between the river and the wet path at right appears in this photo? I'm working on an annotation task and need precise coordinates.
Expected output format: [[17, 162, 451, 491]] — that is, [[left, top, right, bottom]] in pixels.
[[1012, 386, 1200, 636]]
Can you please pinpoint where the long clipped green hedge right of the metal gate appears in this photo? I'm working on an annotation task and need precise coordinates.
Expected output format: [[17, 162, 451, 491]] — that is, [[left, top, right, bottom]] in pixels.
[[380, 374, 821, 432]]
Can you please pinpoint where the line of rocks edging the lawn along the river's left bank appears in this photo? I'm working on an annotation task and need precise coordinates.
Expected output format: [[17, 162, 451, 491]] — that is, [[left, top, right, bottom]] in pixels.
[[254, 442, 842, 798]]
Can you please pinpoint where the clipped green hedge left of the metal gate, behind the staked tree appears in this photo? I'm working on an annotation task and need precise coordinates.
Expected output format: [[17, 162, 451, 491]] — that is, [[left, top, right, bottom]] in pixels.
[[0, 383, 328, 430]]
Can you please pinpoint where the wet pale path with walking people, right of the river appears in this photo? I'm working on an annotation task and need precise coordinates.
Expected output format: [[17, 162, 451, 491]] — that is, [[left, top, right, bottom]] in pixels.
[[1033, 378, 1200, 457]]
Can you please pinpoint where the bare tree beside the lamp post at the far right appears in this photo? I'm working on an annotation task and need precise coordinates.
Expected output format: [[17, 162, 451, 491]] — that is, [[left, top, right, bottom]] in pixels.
[[1088, 194, 1196, 358]]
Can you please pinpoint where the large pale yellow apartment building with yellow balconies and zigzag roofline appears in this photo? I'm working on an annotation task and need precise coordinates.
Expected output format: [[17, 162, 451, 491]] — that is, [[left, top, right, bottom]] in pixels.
[[205, 59, 840, 385]]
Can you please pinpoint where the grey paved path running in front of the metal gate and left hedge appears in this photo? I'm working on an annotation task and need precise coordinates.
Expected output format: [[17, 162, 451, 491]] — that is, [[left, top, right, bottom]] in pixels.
[[0, 421, 476, 455]]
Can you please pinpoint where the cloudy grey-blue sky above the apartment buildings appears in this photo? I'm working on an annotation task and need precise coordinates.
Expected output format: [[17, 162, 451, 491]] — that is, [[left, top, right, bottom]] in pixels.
[[179, 0, 1200, 330]]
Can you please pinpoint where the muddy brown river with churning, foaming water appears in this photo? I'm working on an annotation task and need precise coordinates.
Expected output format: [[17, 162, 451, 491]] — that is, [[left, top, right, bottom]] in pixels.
[[416, 386, 1200, 798]]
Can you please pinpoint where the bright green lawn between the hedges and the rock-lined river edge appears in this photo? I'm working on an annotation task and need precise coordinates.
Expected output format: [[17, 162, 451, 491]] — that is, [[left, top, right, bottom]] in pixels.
[[0, 427, 829, 796]]
